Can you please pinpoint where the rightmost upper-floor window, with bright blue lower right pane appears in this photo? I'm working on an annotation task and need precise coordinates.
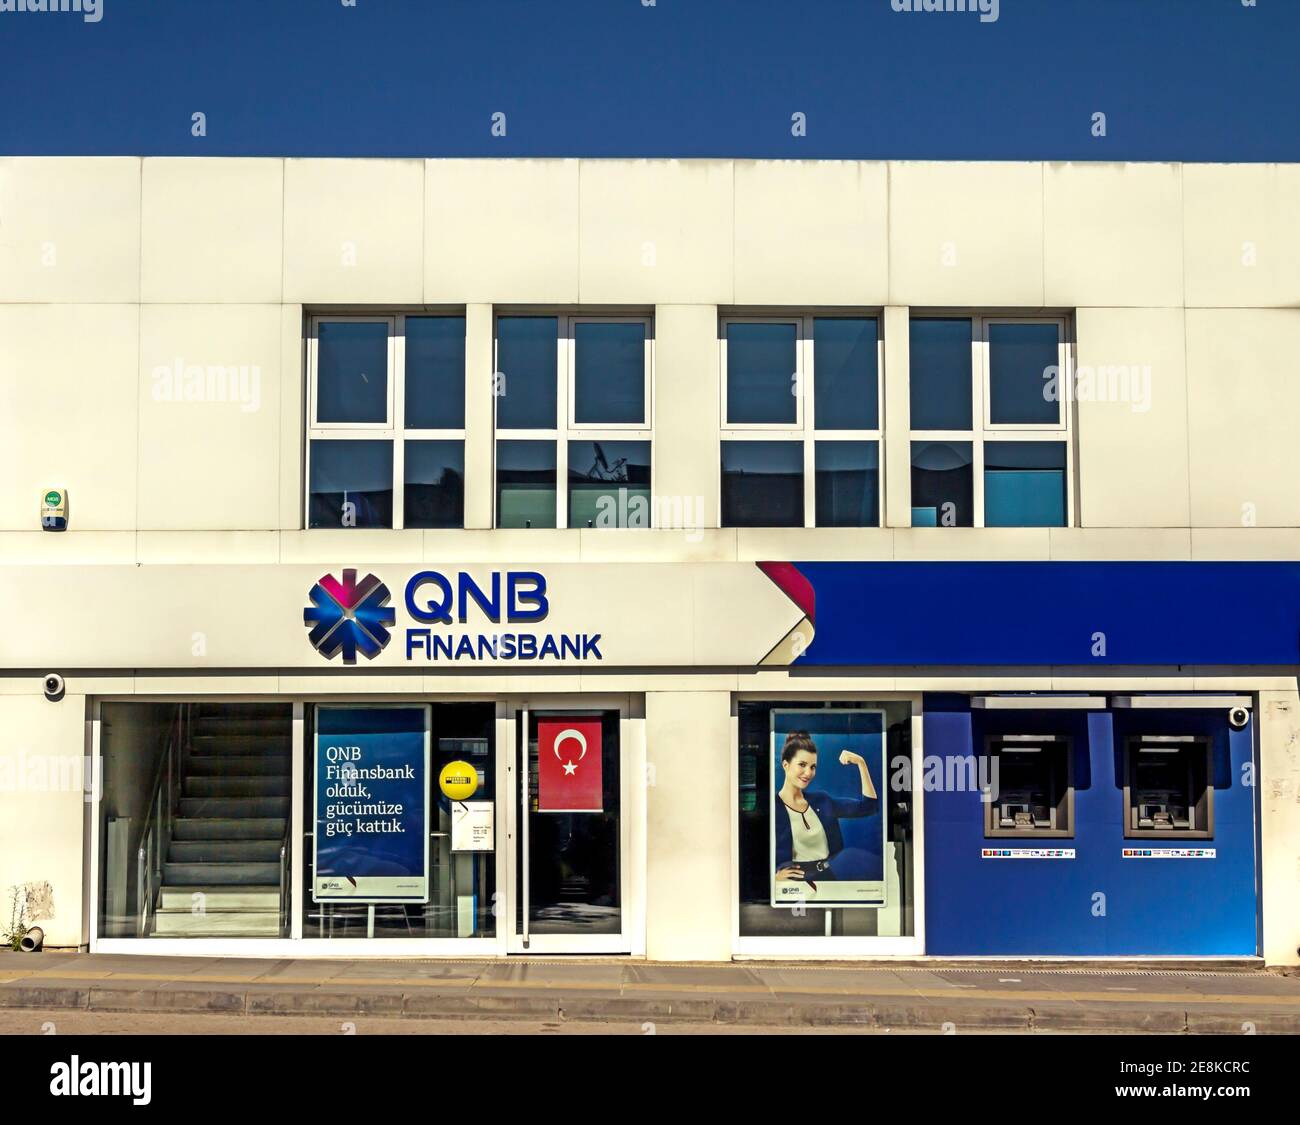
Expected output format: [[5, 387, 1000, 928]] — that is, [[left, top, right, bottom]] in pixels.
[[909, 316, 1073, 527]]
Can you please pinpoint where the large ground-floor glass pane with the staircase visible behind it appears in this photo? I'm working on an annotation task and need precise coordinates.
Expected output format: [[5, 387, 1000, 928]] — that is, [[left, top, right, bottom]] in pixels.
[[95, 697, 295, 940]]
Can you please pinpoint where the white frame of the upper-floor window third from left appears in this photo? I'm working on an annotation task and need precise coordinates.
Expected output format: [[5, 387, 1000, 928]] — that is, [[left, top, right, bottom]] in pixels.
[[714, 308, 887, 531]]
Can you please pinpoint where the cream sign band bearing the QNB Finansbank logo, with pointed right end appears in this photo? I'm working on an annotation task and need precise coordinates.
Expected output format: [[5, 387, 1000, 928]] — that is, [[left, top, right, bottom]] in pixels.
[[0, 561, 813, 675]]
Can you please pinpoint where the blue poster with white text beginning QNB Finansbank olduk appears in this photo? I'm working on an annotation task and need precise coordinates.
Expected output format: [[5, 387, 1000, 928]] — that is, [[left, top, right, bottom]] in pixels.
[[312, 706, 429, 903]]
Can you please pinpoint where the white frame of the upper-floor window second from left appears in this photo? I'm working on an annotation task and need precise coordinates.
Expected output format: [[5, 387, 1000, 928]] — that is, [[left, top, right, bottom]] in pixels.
[[491, 306, 658, 532]]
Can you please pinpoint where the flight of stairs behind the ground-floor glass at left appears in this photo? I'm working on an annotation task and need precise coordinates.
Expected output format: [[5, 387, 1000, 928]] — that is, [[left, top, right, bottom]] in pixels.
[[151, 704, 293, 938]]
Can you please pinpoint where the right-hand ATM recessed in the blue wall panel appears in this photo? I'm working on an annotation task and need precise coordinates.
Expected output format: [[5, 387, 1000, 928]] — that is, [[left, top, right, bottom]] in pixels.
[[1125, 735, 1214, 840]]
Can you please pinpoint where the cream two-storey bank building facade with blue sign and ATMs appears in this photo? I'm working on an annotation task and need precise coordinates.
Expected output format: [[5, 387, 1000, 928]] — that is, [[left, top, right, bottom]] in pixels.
[[0, 157, 1300, 965]]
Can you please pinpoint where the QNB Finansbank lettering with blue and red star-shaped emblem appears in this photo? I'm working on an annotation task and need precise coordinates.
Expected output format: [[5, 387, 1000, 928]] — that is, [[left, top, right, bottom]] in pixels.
[[303, 570, 603, 665]]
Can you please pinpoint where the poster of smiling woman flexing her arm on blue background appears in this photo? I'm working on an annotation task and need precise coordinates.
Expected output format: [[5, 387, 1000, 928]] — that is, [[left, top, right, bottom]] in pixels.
[[771, 709, 888, 908]]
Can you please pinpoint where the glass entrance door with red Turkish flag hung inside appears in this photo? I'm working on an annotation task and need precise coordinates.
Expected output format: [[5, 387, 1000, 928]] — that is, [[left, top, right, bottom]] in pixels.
[[510, 708, 631, 953]]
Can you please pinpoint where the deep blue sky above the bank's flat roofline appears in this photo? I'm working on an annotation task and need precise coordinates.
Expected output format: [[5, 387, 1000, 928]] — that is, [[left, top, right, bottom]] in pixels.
[[0, 0, 1300, 160]]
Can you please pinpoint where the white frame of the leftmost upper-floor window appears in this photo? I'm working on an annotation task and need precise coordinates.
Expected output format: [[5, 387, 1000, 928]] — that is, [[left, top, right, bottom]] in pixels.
[[303, 308, 468, 531]]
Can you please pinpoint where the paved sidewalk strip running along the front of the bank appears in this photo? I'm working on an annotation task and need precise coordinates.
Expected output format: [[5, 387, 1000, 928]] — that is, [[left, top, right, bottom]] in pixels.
[[0, 952, 1300, 1034]]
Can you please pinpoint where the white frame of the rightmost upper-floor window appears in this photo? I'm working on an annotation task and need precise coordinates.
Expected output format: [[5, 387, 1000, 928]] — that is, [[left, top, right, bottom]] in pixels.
[[907, 310, 1078, 531]]
